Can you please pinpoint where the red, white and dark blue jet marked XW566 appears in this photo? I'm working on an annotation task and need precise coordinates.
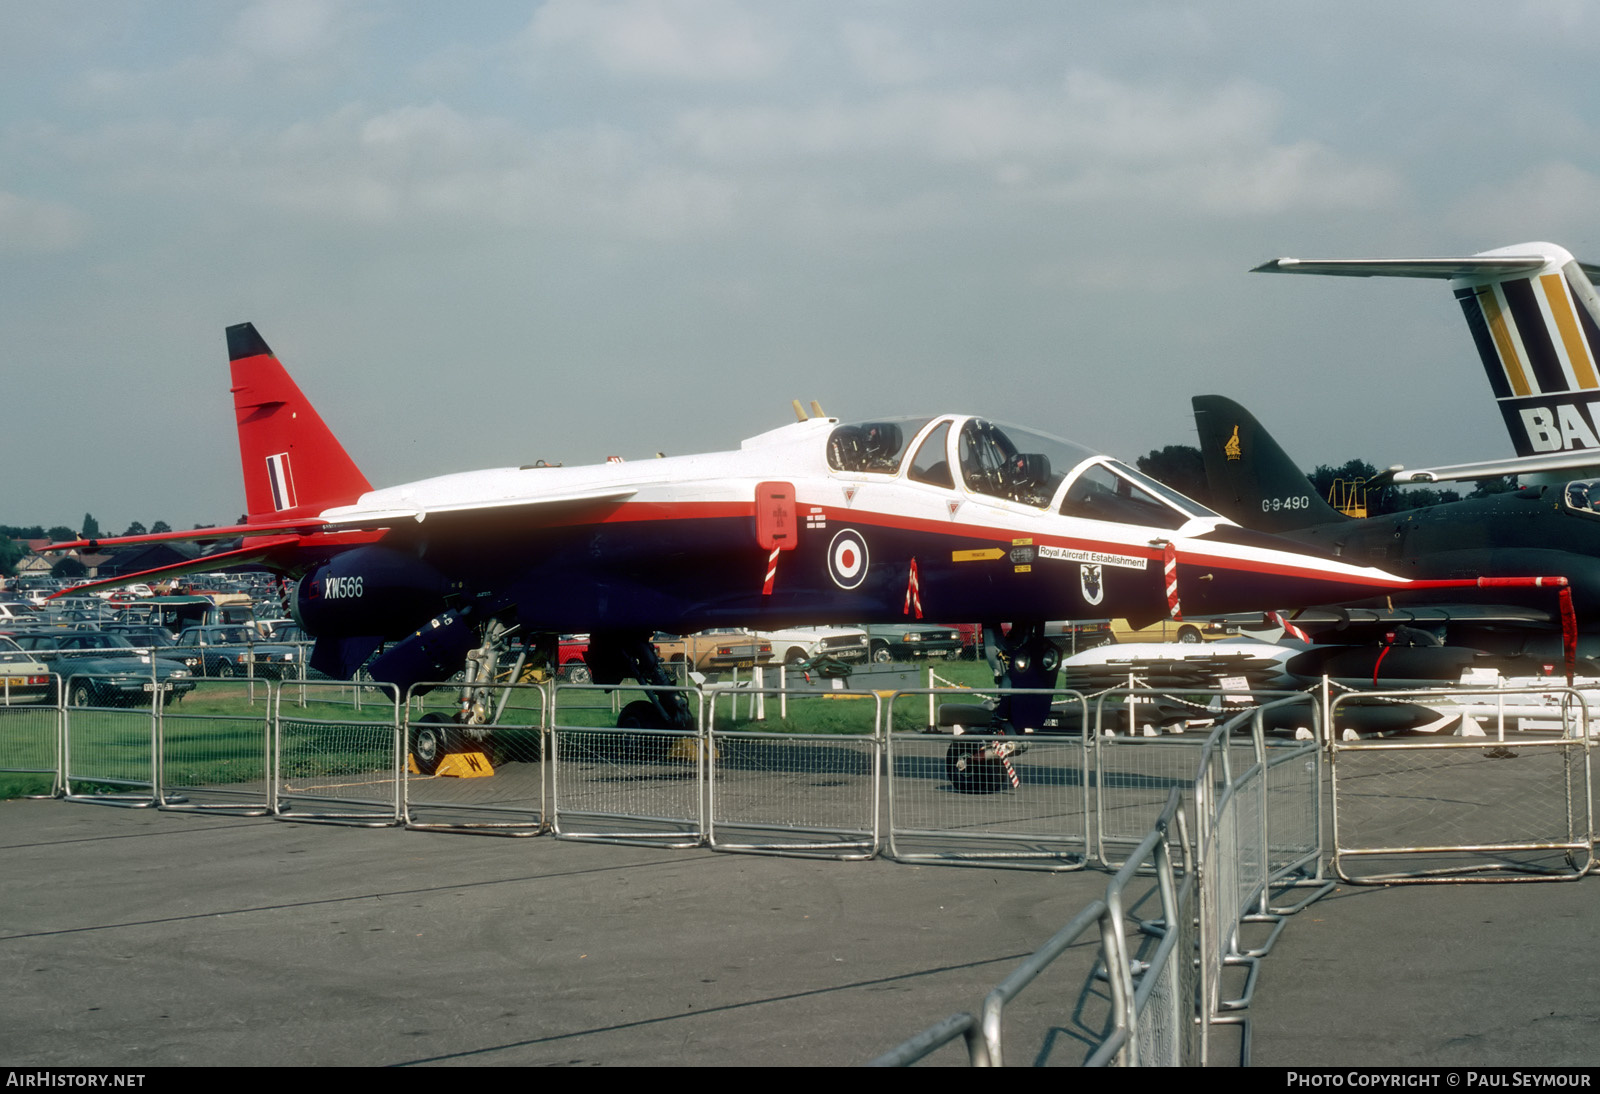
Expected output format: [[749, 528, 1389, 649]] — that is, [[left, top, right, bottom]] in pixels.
[[58, 323, 1548, 754]]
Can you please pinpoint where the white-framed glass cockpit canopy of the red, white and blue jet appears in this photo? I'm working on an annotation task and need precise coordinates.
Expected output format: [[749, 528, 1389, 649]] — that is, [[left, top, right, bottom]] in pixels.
[[827, 417, 1216, 528]]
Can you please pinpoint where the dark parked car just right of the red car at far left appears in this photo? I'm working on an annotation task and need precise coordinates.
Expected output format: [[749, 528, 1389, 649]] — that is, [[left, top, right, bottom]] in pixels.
[[11, 630, 195, 707]]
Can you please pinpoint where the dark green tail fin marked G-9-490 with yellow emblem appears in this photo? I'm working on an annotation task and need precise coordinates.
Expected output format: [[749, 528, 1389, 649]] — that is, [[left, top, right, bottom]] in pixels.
[[1192, 395, 1342, 533]]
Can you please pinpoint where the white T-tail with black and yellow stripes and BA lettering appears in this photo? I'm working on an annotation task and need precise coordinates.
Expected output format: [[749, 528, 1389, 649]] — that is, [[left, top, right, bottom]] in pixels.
[[1256, 243, 1600, 456]]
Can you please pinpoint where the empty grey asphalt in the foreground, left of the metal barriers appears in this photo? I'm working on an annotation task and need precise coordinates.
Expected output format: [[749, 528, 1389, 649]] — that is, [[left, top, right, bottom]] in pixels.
[[0, 801, 1107, 1068]]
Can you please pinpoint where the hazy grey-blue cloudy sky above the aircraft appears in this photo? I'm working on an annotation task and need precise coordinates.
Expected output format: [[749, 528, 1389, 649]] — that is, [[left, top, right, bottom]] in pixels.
[[0, 0, 1600, 533]]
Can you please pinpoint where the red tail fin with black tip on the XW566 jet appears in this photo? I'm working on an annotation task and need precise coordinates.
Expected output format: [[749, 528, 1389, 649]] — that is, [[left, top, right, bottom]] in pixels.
[[227, 323, 373, 525]]
